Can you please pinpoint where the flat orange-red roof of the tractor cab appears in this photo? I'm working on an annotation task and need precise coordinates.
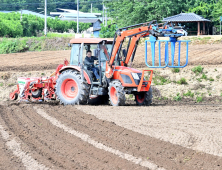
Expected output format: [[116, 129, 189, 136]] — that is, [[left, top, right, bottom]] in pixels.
[[70, 38, 113, 44]]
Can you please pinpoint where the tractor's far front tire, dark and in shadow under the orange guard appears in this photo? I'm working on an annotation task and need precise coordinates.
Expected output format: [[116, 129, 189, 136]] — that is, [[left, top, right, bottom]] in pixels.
[[135, 87, 153, 106]]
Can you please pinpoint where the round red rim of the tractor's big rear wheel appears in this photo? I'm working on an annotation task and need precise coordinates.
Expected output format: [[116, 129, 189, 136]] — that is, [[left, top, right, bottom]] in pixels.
[[61, 79, 78, 100]]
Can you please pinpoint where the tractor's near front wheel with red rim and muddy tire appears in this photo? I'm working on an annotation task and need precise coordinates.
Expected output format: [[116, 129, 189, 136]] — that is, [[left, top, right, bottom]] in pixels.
[[109, 80, 126, 106]]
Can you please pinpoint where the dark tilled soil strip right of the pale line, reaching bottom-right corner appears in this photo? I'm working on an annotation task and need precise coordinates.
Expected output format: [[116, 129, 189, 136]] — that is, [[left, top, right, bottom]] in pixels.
[[41, 105, 222, 169]]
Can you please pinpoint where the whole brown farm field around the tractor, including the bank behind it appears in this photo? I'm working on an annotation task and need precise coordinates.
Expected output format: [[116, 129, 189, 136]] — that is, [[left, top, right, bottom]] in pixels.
[[0, 41, 222, 170]]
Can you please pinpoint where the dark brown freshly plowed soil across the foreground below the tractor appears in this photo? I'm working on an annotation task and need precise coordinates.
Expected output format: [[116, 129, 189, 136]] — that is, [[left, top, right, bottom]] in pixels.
[[0, 103, 222, 170]]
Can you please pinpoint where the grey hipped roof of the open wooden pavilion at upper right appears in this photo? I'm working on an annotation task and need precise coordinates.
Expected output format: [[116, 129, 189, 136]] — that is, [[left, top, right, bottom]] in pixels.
[[163, 13, 210, 22]]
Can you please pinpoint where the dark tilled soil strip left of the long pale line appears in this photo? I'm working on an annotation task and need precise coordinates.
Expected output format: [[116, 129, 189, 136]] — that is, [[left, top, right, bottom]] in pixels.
[[0, 105, 147, 169]]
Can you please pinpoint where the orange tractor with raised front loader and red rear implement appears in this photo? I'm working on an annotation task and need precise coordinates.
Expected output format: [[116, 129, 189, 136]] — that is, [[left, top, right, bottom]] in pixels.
[[10, 21, 188, 106]]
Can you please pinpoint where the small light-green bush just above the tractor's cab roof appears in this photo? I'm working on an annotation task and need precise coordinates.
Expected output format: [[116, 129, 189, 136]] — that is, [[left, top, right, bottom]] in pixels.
[[99, 21, 117, 38]]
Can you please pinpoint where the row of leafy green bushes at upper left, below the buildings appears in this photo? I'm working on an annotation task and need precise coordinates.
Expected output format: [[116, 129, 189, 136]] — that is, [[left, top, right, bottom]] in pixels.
[[0, 13, 91, 38]]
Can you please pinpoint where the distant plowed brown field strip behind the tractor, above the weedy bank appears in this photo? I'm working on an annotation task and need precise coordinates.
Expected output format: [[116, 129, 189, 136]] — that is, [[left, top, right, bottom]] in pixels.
[[0, 44, 222, 71]]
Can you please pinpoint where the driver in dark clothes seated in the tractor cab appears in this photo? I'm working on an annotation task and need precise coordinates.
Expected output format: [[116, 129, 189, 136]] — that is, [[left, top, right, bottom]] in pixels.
[[84, 50, 100, 80]]
